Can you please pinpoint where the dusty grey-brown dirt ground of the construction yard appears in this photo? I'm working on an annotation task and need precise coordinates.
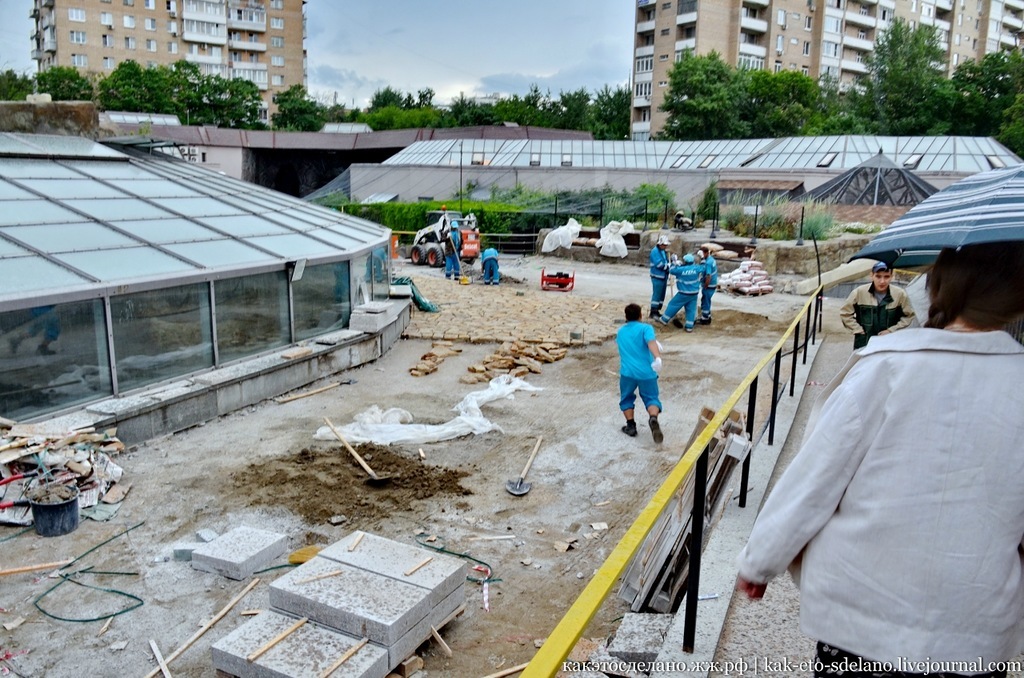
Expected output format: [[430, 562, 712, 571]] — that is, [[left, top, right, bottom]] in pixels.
[[0, 257, 839, 678]]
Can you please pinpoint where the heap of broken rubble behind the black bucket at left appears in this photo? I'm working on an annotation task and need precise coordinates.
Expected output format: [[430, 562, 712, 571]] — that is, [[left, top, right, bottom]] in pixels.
[[0, 419, 130, 525]]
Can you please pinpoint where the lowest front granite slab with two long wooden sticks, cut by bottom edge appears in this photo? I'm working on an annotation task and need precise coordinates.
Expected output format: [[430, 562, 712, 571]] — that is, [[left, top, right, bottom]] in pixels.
[[211, 611, 388, 678]]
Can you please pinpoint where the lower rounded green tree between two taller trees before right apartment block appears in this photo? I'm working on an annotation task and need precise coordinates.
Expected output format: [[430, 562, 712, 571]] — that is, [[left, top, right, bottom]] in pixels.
[[742, 71, 818, 138]]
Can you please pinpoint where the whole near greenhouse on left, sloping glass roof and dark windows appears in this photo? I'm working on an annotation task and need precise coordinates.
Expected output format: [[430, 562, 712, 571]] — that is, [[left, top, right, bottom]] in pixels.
[[0, 133, 390, 423]]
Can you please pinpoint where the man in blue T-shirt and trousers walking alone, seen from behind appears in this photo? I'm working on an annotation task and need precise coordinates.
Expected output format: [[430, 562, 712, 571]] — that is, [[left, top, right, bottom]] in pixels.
[[615, 304, 665, 443]]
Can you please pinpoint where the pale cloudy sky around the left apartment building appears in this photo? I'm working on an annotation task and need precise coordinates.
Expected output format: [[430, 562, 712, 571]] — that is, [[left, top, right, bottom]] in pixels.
[[0, 0, 636, 108]]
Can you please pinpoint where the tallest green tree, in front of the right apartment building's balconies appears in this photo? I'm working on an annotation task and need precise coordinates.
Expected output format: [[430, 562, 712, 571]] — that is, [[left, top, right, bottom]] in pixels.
[[860, 18, 952, 136]]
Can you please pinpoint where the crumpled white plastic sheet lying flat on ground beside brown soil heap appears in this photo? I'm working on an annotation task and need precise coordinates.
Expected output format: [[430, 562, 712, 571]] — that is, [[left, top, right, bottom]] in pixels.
[[313, 375, 544, 444]]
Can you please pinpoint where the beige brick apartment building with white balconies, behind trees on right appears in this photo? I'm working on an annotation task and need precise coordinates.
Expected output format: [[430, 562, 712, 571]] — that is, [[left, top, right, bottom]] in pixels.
[[632, 0, 1024, 140]]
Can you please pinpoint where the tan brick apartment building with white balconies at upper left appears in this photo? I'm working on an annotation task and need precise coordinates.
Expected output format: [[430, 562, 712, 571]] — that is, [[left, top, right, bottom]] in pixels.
[[31, 0, 306, 122]]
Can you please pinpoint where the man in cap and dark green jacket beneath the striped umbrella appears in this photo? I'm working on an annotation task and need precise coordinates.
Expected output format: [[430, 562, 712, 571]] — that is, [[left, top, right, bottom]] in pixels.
[[839, 261, 913, 350]]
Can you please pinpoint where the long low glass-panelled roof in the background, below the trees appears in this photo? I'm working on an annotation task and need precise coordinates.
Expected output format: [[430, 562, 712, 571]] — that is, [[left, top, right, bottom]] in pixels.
[[383, 135, 1021, 173]]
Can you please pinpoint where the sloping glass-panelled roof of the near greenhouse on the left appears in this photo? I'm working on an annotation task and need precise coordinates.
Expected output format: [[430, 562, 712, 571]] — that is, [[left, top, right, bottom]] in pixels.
[[0, 133, 388, 301]]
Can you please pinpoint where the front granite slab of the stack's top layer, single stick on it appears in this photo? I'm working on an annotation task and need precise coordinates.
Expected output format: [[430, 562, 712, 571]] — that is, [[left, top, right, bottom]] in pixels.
[[270, 556, 431, 647]]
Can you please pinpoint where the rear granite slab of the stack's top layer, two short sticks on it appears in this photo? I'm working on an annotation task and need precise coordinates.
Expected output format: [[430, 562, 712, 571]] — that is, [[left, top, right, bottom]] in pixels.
[[318, 532, 468, 607]]
